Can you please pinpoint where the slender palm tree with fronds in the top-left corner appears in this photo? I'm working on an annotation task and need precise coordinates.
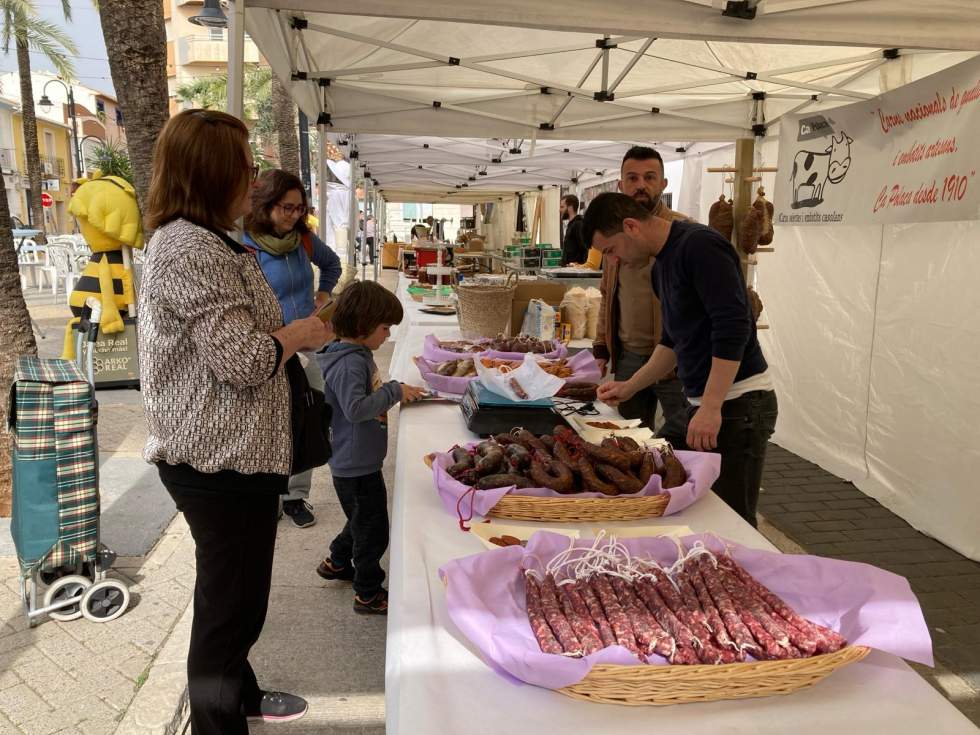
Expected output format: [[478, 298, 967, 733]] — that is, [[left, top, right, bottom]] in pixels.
[[0, 0, 77, 242]]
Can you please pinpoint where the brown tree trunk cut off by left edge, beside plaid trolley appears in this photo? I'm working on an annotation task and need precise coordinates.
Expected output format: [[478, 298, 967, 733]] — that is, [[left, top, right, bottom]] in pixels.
[[0, 165, 37, 517]]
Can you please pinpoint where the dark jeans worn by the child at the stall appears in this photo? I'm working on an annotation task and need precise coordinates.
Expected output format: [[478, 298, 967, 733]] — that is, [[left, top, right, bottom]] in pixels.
[[330, 471, 388, 600]]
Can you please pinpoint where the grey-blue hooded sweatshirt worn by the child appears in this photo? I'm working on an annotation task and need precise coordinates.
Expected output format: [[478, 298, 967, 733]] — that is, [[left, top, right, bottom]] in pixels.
[[316, 341, 402, 477]]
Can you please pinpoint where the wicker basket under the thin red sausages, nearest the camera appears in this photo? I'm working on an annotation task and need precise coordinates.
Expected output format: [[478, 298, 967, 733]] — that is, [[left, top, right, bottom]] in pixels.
[[556, 646, 868, 706]]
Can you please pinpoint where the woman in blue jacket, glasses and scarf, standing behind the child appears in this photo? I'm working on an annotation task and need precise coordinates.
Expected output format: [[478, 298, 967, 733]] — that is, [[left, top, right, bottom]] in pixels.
[[243, 169, 341, 528]]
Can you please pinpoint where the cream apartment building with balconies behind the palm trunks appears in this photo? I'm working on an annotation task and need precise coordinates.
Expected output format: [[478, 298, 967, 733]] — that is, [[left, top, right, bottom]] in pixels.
[[162, 0, 260, 115]]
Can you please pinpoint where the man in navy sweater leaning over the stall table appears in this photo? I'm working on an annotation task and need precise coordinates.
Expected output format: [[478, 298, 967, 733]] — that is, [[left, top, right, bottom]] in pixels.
[[584, 193, 777, 526]]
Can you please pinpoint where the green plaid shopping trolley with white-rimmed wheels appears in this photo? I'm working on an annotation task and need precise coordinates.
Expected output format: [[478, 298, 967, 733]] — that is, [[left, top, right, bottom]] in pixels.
[[7, 356, 129, 625]]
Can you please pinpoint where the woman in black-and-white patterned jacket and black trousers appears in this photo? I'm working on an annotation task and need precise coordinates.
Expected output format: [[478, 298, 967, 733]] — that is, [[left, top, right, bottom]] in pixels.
[[138, 110, 333, 735]]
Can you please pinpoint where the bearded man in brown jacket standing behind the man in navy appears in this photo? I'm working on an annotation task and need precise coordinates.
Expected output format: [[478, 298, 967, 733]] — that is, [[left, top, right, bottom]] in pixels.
[[592, 146, 690, 442]]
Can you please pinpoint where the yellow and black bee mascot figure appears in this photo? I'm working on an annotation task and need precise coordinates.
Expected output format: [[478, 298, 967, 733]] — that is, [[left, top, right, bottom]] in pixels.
[[62, 172, 143, 360]]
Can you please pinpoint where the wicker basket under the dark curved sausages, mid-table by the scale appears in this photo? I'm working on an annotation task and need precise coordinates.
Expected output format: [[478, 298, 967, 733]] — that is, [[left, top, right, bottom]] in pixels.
[[422, 454, 670, 523]]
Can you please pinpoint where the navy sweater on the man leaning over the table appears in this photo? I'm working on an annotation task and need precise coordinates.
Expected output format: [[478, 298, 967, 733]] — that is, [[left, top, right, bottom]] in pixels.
[[650, 222, 768, 398]]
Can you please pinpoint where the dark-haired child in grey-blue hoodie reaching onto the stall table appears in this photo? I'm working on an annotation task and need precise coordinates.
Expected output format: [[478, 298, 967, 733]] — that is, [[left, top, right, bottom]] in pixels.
[[316, 281, 426, 615]]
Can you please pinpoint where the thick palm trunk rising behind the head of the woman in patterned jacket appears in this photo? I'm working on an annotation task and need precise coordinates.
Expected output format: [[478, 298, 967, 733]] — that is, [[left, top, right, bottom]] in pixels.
[[99, 0, 170, 217]]
